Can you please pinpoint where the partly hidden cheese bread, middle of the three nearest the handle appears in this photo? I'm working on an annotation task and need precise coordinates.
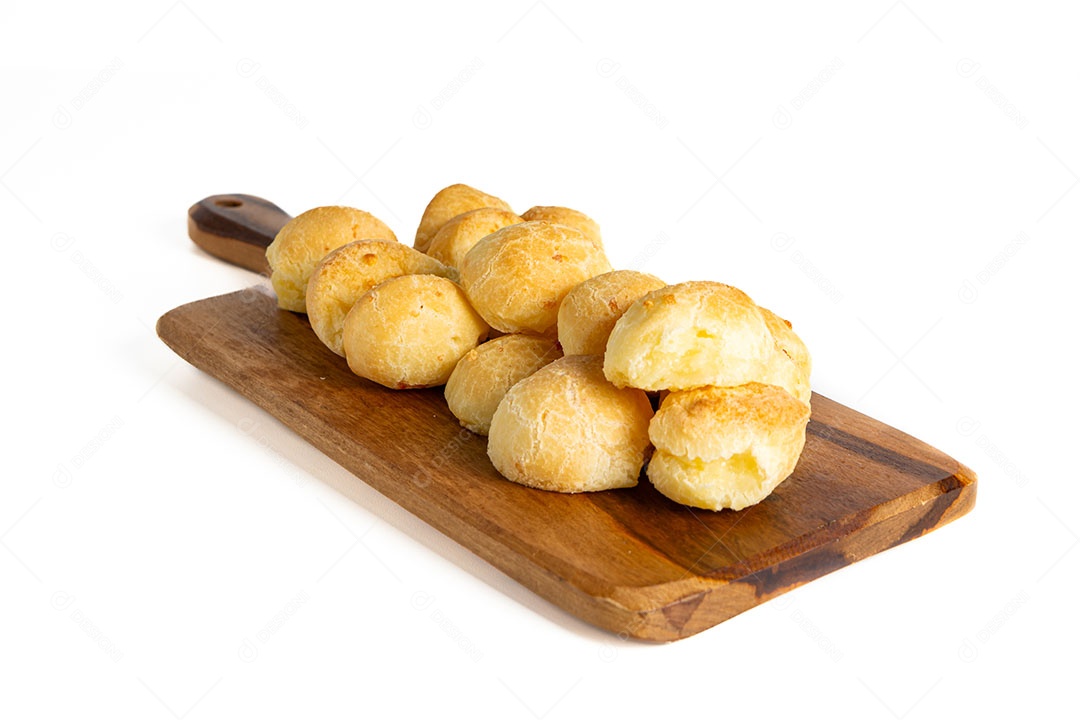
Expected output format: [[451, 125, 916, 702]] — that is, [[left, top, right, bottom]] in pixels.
[[306, 240, 457, 356]]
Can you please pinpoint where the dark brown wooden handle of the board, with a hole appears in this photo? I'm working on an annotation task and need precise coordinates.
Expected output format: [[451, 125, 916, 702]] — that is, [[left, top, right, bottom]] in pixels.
[[188, 194, 293, 275]]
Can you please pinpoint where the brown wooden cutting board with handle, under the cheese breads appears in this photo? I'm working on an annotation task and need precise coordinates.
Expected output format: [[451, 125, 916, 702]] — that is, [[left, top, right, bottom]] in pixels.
[[158, 195, 976, 640]]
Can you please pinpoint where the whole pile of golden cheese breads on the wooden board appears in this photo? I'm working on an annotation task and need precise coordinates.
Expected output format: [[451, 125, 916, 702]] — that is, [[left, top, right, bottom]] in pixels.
[[267, 185, 810, 511]]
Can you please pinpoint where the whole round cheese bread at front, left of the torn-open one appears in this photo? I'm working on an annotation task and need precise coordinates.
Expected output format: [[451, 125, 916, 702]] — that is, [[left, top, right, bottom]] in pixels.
[[487, 355, 652, 492]]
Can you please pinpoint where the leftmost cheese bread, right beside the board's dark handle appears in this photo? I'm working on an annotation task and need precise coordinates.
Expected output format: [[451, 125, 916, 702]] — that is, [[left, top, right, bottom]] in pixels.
[[267, 205, 397, 312]]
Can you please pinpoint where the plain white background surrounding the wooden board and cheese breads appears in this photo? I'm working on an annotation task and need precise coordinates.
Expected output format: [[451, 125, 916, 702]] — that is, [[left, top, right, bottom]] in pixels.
[[0, 0, 1080, 720]]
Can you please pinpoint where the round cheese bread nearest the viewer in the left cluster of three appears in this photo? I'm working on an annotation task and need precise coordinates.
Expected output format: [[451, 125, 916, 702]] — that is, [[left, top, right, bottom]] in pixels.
[[342, 275, 488, 390]]
